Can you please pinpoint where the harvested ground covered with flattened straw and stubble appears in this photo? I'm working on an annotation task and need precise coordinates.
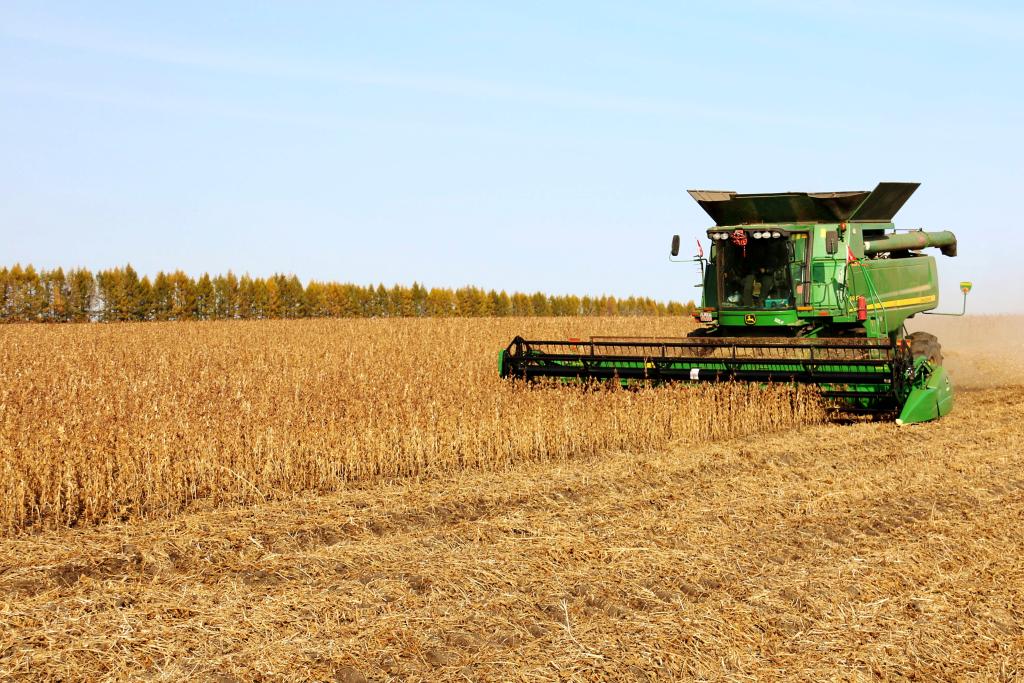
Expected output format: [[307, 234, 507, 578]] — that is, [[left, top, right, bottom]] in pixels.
[[0, 318, 1024, 683]]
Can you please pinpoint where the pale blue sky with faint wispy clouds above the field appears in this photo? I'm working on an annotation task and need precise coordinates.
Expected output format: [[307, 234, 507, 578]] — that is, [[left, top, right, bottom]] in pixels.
[[0, 0, 1024, 312]]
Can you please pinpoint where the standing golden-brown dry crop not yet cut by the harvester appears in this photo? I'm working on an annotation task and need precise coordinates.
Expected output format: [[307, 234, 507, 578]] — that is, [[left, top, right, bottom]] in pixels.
[[0, 318, 821, 531]]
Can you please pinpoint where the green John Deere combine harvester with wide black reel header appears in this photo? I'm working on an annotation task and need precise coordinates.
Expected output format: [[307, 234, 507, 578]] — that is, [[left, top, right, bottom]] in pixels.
[[499, 182, 971, 424]]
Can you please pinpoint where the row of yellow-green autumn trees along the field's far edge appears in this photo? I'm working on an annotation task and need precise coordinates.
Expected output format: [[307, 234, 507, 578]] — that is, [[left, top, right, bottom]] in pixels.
[[0, 265, 694, 323]]
